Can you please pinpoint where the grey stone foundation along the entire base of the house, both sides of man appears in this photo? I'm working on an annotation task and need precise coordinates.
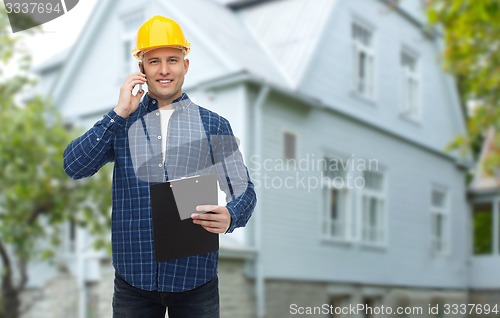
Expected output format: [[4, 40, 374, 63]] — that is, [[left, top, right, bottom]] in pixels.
[[22, 257, 474, 318]]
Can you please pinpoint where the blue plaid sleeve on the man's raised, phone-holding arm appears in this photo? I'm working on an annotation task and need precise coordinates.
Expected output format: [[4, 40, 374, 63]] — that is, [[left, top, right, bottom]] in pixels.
[[63, 110, 125, 179]]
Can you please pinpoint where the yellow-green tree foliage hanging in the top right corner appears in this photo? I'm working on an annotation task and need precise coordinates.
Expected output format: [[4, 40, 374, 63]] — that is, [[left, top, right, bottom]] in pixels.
[[427, 0, 500, 172]]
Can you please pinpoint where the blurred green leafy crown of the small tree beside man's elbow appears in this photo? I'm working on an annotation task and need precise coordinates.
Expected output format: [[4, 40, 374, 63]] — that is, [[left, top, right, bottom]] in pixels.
[[0, 97, 111, 258]]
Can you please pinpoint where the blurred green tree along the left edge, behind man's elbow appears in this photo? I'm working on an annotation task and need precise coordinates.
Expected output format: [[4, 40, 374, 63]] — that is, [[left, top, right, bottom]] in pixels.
[[0, 7, 111, 318]]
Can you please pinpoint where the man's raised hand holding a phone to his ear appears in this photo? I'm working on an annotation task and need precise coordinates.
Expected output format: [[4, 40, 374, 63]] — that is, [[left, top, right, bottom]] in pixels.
[[114, 73, 146, 118]]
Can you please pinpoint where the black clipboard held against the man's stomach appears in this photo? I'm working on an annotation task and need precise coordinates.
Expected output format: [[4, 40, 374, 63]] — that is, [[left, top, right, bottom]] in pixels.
[[150, 174, 219, 262]]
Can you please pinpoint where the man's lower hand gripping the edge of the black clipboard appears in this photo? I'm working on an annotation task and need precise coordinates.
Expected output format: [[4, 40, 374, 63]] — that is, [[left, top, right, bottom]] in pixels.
[[191, 205, 231, 234]]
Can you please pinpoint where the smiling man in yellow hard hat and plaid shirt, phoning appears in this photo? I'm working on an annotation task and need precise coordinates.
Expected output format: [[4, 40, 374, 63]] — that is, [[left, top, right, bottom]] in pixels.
[[64, 16, 256, 318]]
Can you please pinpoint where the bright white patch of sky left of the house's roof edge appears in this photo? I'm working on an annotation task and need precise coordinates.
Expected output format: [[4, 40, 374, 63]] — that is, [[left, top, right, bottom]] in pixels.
[[20, 0, 97, 66]]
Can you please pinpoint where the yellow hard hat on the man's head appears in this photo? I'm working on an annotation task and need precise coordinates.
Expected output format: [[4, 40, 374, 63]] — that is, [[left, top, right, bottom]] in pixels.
[[132, 15, 191, 59]]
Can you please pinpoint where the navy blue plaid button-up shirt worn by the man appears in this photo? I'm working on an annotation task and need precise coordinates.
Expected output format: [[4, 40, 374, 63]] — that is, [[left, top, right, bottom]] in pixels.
[[64, 94, 256, 292]]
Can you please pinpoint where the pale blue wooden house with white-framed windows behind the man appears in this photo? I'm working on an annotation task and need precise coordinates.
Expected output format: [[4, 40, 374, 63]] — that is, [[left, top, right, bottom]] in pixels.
[[28, 0, 476, 318]]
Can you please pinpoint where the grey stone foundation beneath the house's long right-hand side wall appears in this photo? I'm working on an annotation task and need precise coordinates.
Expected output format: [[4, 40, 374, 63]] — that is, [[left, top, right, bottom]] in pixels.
[[266, 280, 470, 318]]
